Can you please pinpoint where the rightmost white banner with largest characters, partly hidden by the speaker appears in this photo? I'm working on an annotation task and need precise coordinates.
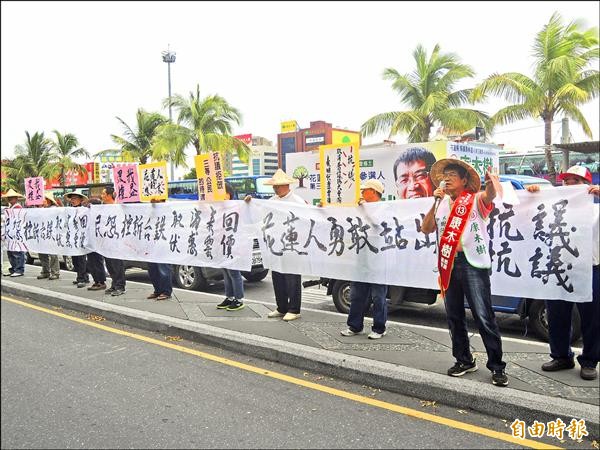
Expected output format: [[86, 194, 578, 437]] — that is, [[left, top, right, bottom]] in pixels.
[[252, 188, 597, 302]]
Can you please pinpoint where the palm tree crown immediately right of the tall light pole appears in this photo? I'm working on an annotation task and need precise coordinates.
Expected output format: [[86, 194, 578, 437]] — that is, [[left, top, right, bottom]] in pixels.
[[153, 85, 250, 166]]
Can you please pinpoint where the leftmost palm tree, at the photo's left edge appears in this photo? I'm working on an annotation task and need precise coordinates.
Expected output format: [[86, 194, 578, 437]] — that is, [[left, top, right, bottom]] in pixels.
[[2, 131, 52, 191]]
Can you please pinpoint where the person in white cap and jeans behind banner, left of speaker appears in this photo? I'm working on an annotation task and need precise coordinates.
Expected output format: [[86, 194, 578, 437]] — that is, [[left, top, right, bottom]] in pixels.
[[340, 180, 387, 339]]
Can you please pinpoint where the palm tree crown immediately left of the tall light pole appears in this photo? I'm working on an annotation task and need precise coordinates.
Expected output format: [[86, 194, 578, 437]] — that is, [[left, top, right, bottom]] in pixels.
[[96, 108, 168, 164]]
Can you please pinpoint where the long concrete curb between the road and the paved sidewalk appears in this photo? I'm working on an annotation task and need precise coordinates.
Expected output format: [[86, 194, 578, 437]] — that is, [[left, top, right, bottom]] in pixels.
[[2, 280, 600, 436]]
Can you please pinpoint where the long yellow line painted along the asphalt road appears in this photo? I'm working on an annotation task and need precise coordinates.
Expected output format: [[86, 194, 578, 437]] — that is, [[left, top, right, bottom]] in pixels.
[[2, 295, 561, 449]]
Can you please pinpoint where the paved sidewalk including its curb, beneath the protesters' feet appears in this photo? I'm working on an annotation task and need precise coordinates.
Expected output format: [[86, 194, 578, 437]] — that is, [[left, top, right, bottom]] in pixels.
[[2, 266, 600, 437]]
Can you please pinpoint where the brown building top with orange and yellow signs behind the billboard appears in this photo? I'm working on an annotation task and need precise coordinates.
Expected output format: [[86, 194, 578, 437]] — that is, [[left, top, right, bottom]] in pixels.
[[277, 120, 362, 170]]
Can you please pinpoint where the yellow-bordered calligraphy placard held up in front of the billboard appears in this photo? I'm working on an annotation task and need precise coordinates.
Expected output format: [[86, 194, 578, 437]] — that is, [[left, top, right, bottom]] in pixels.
[[319, 142, 360, 206]]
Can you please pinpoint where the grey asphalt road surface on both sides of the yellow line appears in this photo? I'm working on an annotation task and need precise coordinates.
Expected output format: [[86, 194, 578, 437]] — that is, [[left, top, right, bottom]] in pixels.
[[0, 298, 557, 448]]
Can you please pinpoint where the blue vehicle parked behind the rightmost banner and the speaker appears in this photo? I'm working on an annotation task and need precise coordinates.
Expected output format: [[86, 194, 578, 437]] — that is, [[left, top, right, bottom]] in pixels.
[[303, 175, 581, 342]]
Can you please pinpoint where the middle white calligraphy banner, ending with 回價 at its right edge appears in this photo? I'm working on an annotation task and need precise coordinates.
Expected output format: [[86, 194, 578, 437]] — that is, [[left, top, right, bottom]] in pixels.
[[90, 201, 256, 271]]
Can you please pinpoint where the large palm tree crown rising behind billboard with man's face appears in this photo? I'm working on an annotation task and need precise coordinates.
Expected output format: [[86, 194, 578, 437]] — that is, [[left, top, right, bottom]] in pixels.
[[361, 45, 491, 142]]
